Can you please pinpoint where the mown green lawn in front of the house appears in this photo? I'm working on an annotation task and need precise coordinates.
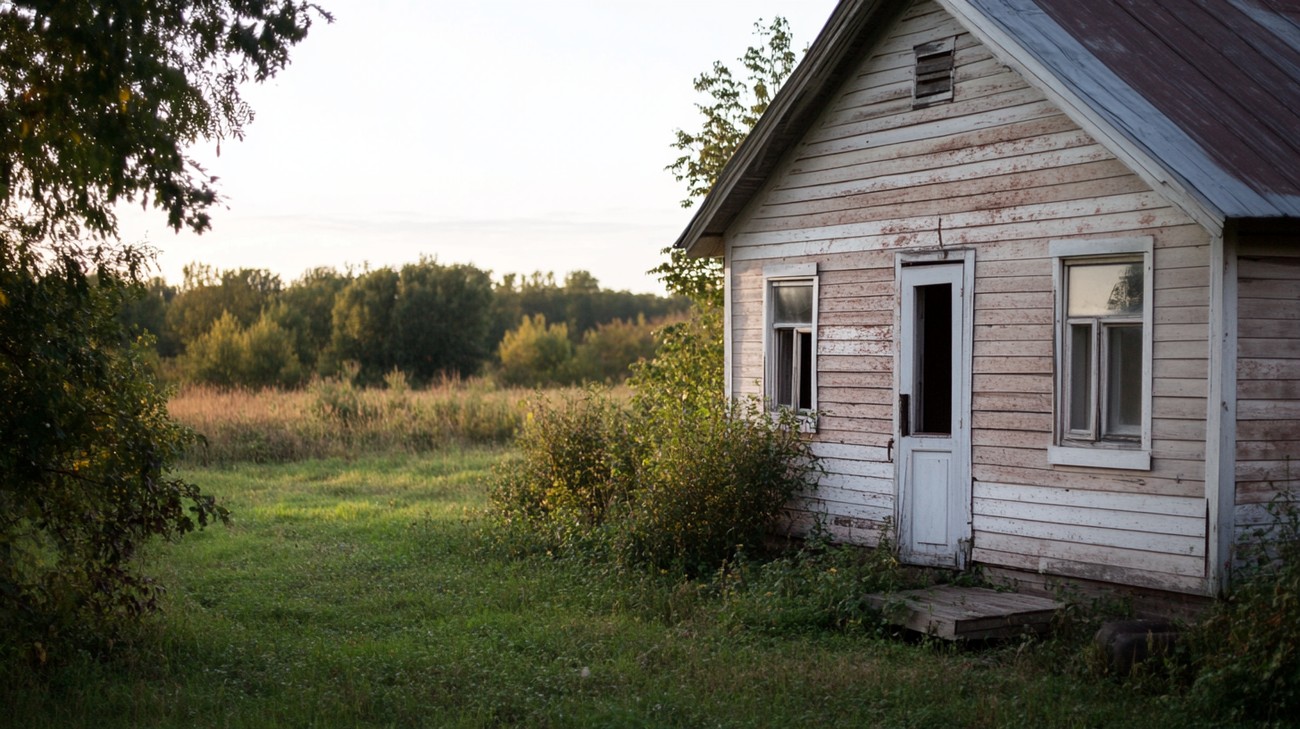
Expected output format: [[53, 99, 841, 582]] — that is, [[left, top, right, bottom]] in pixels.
[[0, 451, 1192, 729]]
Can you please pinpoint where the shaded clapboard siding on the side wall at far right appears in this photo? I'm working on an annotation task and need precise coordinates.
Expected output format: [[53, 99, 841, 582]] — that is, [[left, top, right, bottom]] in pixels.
[[1235, 253, 1300, 541]]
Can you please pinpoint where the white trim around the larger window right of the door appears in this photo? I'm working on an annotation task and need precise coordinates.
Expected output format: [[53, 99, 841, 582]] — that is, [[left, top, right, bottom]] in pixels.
[[1048, 235, 1156, 470]]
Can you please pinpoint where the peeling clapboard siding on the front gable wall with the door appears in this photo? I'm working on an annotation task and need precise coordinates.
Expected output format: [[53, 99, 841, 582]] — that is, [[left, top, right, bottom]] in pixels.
[[727, 1, 1216, 591]]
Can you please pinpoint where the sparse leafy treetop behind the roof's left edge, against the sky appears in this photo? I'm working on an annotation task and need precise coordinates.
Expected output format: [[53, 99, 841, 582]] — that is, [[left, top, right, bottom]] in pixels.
[[650, 17, 796, 305]]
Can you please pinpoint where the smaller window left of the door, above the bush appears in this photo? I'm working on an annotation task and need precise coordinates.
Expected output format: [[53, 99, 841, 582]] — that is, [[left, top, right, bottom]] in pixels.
[[764, 266, 816, 412]]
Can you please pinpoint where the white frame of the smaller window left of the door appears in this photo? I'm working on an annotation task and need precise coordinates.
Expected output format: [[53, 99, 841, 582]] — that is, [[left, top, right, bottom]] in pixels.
[[763, 264, 819, 426]]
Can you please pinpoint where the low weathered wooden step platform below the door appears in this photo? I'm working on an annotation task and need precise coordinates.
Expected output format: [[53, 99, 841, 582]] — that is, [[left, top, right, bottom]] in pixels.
[[867, 585, 1065, 641]]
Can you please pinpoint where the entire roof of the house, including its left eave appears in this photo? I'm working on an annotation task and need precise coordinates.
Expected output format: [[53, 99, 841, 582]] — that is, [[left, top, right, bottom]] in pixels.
[[676, 0, 1300, 255]]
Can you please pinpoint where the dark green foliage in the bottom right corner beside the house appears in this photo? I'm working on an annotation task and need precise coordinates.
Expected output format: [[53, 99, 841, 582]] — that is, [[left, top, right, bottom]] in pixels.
[[1188, 495, 1300, 723]]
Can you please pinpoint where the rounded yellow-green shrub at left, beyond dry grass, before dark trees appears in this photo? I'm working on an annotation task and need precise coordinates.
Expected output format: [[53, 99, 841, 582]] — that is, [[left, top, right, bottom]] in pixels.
[[181, 312, 303, 387]]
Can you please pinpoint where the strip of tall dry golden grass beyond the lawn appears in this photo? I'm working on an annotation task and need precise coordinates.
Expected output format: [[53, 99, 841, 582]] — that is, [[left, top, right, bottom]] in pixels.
[[170, 378, 574, 465]]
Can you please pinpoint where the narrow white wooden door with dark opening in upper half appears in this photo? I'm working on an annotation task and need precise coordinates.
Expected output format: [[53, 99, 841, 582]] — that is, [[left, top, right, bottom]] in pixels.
[[897, 262, 971, 568]]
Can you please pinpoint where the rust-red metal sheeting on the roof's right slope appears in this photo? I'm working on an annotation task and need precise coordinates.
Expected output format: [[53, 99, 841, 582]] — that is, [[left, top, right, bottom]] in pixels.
[[1034, 0, 1300, 216]]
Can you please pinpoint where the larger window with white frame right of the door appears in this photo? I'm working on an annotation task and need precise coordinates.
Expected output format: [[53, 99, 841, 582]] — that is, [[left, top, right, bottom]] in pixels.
[[1049, 238, 1152, 469]]
